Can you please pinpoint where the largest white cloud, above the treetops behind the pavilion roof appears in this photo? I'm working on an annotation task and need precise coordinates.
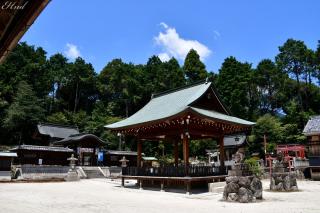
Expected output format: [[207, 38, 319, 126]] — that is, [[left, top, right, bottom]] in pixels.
[[154, 22, 211, 60]]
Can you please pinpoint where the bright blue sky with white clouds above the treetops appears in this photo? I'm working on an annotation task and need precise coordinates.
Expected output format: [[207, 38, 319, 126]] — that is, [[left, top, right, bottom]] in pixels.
[[21, 0, 320, 72]]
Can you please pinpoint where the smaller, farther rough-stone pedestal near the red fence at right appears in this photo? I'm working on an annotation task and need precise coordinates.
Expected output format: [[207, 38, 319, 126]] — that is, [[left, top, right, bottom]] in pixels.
[[270, 172, 298, 191]]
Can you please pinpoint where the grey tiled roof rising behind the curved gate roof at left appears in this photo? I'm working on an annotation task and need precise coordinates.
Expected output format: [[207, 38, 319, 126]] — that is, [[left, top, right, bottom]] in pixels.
[[37, 123, 79, 139]]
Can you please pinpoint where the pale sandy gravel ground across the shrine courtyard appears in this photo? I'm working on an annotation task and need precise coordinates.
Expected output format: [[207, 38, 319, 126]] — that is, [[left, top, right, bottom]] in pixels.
[[0, 179, 320, 213]]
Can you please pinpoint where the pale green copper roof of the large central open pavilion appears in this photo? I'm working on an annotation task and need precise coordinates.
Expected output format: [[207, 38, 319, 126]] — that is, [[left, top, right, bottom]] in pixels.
[[105, 82, 254, 129]]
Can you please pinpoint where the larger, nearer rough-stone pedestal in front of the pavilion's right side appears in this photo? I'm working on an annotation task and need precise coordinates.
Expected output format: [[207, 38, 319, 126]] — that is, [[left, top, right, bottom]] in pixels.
[[223, 176, 262, 203]]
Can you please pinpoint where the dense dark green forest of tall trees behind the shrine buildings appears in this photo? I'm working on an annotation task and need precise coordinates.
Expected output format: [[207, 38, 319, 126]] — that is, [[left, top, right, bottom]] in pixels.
[[0, 39, 320, 158]]
